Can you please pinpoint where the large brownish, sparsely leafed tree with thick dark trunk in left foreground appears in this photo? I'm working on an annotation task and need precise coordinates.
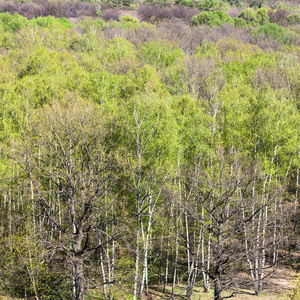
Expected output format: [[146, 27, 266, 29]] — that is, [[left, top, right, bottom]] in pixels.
[[9, 97, 115, 300]]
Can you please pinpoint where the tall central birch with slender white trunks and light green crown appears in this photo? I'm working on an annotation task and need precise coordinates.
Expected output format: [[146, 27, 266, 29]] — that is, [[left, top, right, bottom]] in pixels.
[[118, 93, 177, 299]]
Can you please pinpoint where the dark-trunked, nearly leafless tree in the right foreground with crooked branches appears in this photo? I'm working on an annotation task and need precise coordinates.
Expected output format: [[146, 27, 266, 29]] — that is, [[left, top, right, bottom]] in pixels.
[[185, 147, 265, 300]]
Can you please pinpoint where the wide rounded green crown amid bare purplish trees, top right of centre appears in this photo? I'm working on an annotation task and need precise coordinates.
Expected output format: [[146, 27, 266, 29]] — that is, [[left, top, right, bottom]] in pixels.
[[192, 11, 233, 26]]
